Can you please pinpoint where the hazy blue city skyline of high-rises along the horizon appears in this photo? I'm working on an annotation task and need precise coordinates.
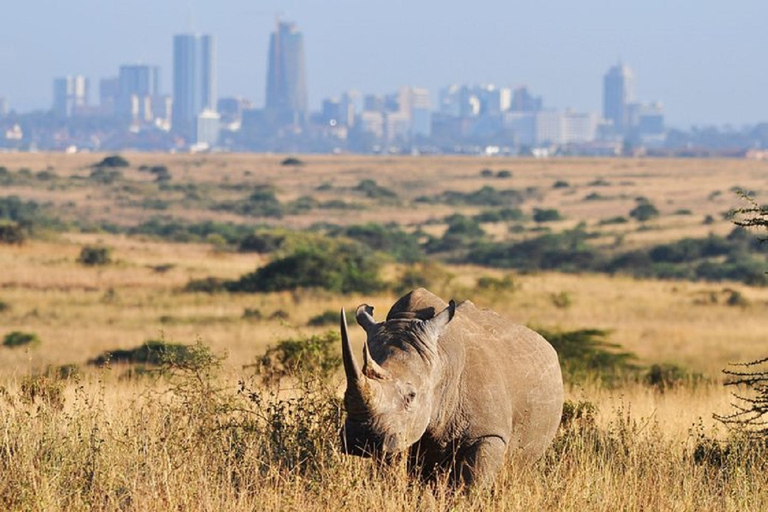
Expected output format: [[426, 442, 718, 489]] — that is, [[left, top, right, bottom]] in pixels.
[[0, 21, 665, 154]]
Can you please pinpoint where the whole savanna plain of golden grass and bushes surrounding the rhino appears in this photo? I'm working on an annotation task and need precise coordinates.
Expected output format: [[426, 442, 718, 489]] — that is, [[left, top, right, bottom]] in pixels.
[[0, 154, 768, 510]]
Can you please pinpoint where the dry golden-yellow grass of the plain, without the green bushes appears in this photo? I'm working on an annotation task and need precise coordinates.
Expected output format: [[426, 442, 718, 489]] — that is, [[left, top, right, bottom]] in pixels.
[[0, 154, 768, 510]]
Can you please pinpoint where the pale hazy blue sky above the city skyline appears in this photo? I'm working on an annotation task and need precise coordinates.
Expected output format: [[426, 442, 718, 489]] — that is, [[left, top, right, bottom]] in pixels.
[[0, 0, 768, 128]]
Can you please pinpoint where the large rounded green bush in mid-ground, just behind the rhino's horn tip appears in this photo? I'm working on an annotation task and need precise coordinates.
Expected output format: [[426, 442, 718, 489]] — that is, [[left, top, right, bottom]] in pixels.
[[226, 240, 383, 293]]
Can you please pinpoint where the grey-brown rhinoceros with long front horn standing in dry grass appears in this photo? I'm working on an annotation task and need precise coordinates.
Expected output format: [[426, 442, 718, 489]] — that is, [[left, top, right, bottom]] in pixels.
[[340, 288, 563, 487]]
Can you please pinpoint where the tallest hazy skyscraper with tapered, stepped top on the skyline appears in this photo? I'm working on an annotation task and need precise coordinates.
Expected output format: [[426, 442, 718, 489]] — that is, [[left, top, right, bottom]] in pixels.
[[265, 22, 307, 126]]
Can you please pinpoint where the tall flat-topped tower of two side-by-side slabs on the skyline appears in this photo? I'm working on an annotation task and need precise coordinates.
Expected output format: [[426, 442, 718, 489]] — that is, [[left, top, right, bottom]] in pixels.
[[173, 34, 216, 140]]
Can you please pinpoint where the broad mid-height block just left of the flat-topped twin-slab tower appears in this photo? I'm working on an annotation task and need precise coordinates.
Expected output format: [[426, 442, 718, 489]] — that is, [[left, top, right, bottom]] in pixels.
[[117, 64, 160, 122]]
